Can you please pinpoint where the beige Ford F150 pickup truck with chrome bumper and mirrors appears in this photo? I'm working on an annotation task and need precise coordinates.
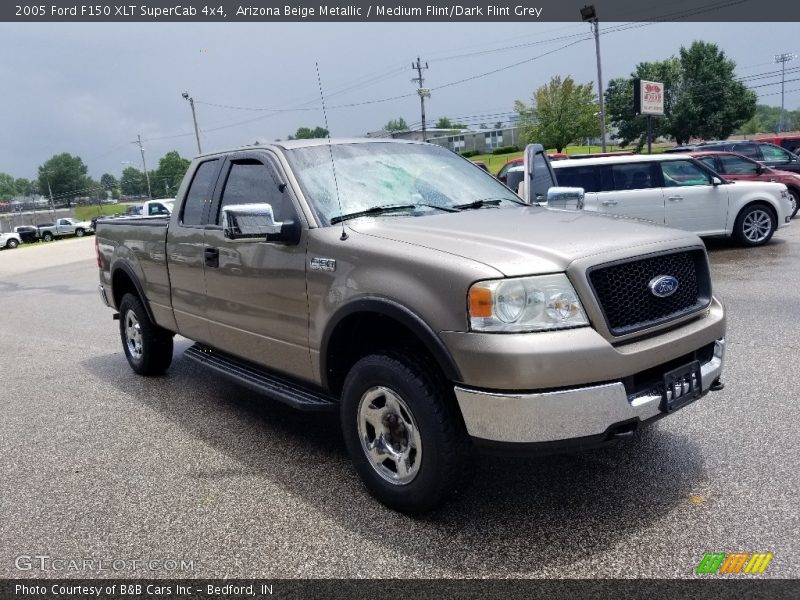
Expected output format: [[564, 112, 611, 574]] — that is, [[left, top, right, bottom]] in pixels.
[[96, 140, 725, 513]]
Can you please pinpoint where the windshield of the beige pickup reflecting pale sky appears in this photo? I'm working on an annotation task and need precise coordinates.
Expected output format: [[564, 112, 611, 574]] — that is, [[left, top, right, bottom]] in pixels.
[[287, 142, 521, 225]]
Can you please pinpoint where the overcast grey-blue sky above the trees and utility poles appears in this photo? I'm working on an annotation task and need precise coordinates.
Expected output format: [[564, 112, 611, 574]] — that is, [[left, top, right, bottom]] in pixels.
[[0, 22, 800, 178]]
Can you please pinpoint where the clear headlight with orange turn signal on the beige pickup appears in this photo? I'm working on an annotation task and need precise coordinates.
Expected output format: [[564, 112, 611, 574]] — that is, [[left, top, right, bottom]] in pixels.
[[469, 273, 589, 333]]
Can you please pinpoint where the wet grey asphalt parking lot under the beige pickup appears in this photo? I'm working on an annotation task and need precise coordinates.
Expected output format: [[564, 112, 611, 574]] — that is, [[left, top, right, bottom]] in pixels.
[[0, 229, 800, 578]]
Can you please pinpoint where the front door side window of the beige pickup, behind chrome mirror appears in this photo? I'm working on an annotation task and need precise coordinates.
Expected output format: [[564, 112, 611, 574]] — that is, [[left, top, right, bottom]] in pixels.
[[217, 160, 295, 225]]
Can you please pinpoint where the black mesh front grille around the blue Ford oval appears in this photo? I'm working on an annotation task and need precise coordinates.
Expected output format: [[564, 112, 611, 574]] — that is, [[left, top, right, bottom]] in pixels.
[[589, 250, 711, 335]]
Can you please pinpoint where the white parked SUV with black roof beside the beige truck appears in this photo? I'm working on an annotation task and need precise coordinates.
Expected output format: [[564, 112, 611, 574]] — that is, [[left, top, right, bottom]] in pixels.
[[553, 154, 792, 246]]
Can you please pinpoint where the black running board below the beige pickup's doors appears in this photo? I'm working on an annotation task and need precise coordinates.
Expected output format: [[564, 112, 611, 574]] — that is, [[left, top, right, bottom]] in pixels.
[[184, 344, 339, 411]]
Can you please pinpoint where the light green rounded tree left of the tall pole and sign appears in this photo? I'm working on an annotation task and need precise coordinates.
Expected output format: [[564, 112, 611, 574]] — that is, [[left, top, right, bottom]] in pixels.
[[514, 76, 600, 152]]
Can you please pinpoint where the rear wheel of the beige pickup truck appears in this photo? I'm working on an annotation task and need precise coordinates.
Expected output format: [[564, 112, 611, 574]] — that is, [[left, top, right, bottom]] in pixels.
[[119, 294, 172, 375]]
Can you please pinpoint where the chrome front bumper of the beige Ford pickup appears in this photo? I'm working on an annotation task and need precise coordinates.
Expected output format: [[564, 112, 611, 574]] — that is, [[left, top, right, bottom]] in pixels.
[[455, 338, 725, 443]]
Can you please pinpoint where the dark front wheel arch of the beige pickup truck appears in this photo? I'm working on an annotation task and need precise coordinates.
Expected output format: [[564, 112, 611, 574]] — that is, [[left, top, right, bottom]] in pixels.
[[319, 297, 461, 394]]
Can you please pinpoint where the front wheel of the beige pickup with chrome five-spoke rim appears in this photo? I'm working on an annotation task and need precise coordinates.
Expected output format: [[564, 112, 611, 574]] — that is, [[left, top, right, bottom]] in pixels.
[[341, 353, 473, 514]]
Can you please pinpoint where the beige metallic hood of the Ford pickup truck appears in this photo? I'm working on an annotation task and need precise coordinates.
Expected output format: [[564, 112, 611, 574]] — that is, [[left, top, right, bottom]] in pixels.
[[348, 207, 702, 277]]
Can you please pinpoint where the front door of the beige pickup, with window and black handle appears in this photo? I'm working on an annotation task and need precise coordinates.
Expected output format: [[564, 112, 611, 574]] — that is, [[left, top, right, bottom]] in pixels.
[[204, 152, 313, 379]]
